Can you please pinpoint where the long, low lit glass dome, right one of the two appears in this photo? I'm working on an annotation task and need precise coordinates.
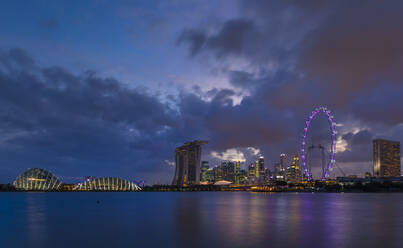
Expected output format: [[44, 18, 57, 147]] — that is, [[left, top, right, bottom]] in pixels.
[[75, 177, 141, 191]]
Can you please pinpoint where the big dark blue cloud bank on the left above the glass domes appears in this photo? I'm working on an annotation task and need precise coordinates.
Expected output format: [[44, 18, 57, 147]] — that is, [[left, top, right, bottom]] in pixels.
[[0, 49, 183, 182]]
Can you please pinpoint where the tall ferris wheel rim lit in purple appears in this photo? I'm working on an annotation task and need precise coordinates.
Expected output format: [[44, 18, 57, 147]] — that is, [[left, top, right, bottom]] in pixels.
[[301, 107, 336, 180]]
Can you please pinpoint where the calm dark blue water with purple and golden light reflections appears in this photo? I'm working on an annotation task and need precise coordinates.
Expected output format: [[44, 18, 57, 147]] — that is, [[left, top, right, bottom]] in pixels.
[[0, 192, 403, 248]]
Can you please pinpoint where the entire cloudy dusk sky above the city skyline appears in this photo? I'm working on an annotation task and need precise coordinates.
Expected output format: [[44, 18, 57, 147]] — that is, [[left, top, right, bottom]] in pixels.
[[0, 0, 403, 184]]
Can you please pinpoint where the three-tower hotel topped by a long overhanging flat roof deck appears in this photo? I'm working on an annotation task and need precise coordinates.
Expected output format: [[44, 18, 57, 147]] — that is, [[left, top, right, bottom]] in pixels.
[[172, 140, 207, 186]]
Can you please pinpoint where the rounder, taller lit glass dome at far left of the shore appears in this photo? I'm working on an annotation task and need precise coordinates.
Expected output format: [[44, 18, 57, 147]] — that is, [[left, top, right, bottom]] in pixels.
[[14, 168, 61, 191]]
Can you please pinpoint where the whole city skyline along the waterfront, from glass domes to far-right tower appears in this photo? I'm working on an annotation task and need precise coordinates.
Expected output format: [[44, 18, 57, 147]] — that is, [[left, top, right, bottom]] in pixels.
[[7, 136, 403, 188]]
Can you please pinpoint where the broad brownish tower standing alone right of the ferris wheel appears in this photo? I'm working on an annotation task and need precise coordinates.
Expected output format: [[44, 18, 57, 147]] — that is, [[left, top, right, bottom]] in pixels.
[[372, 139, 401, 177]]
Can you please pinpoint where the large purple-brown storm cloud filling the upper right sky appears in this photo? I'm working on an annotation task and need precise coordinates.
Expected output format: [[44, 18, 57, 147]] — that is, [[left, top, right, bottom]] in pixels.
[[181, 1, 403, 112]]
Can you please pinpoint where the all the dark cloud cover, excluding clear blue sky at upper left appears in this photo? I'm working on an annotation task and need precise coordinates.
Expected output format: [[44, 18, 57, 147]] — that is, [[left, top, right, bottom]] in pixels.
[[0, 0, 403, 183]]
